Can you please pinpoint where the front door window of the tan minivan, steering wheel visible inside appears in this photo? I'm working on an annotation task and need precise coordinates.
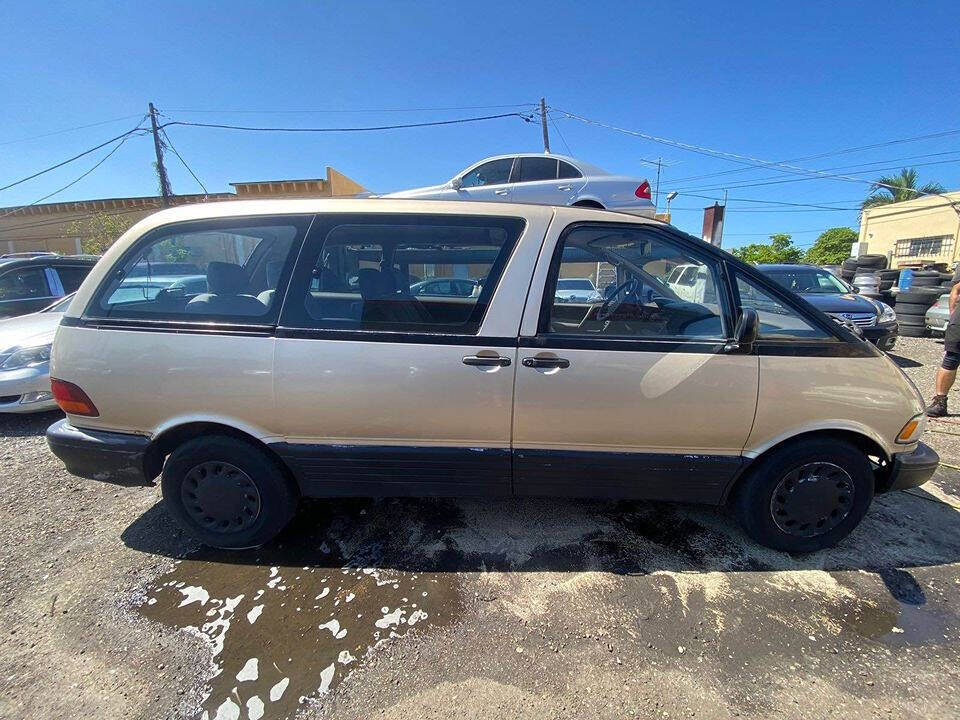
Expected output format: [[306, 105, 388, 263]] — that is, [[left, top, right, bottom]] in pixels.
[[540, 225, 725, 340]]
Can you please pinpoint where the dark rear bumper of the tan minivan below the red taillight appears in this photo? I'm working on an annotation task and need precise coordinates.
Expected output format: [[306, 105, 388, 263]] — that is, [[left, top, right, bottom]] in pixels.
[[47, 419, 151, 485]]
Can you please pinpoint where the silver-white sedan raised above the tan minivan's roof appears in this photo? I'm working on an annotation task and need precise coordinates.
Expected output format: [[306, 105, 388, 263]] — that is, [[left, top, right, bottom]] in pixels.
[[383, 153, 655, 217]]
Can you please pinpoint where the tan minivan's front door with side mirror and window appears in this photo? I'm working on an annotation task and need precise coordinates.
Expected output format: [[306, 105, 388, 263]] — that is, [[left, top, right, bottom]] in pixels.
[[513, 223, 759, 502]]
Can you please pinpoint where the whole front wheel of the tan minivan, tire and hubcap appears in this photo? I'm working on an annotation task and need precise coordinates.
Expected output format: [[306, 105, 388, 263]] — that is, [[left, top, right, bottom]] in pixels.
[[733, 439, 874, 553]]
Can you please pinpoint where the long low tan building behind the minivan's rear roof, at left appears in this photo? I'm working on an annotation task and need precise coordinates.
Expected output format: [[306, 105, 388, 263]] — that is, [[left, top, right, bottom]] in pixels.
[[0, 167, 366, 255]]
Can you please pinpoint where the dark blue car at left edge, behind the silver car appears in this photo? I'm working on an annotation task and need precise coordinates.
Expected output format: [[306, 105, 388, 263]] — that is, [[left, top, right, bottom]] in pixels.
[[0, 253, 97, 320]]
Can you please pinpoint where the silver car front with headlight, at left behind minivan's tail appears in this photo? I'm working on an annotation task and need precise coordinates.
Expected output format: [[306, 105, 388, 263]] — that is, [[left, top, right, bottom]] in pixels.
[[0, 293, 73, 413]]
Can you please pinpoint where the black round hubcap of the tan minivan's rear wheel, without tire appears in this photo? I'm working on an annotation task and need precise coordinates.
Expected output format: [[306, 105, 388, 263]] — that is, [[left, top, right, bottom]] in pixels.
[[180, 460, 260, 535]]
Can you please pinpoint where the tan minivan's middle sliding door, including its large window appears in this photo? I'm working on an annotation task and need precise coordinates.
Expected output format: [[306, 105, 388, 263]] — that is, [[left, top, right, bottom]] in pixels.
[[274, 213, 532, 496]]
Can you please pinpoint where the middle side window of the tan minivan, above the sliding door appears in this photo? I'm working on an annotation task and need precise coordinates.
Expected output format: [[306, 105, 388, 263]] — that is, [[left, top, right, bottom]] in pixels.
[[283, 215, 524, 334]]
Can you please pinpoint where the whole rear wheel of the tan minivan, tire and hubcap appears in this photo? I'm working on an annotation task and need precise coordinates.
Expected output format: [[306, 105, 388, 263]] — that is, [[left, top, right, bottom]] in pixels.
[[160, 435, 299, 550]]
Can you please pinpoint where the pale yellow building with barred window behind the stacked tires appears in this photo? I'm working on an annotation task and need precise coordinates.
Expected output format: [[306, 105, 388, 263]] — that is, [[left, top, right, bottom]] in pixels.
[[860, 191, 960, 268]]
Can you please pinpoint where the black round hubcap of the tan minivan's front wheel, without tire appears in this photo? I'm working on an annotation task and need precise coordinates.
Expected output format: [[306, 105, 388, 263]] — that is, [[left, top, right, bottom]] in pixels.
[[770, 462, 854, 537]]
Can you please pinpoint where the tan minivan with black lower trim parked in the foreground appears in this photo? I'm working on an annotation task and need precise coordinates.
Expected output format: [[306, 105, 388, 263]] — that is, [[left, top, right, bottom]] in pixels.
[[47, 199, 938, 552]]
